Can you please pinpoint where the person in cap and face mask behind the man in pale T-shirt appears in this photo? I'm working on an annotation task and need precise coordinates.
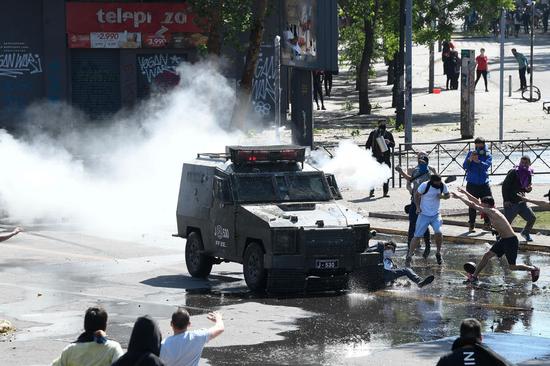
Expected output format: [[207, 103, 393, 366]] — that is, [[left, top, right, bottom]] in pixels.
[[395, 152, 436, 254]]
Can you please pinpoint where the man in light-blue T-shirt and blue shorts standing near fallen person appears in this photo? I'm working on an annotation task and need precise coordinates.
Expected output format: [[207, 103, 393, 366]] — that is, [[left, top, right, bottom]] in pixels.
[[405, 174, 450, 267]]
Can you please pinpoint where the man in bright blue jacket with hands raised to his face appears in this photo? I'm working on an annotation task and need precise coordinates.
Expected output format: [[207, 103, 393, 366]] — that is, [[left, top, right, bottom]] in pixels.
[[462, 137, 493, 232]]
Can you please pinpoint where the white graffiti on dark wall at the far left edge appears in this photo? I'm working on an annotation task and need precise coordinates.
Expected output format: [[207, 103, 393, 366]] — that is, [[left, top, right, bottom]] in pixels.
[[0, 42, 42, 78]]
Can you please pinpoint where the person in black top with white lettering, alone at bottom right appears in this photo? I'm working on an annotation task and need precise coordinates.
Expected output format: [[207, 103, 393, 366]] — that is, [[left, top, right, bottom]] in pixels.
[[437, 318, 513, 366]]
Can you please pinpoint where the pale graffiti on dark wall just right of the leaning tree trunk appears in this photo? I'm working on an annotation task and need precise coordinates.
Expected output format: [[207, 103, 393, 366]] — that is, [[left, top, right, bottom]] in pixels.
[[252, 45, 276, 119]]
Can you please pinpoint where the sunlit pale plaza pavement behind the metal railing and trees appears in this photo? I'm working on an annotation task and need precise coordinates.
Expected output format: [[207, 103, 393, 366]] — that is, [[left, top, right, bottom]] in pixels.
[[314, 35, 550, 145]]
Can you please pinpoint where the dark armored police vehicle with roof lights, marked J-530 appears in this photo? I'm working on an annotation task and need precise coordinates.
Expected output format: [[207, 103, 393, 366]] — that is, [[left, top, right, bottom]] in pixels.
[[177, 146, 381, 292]]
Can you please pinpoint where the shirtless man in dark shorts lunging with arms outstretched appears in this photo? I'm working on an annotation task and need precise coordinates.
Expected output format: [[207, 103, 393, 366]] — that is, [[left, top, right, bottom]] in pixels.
[[452, 188, 540, 283]]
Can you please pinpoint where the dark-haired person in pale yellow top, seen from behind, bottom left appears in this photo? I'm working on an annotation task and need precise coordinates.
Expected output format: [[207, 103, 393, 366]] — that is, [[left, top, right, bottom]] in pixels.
[[52, 307, 122, 366]]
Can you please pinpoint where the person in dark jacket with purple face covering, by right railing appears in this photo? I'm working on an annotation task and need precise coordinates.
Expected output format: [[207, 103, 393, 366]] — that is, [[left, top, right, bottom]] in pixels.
[[502, 156, 537, 242]]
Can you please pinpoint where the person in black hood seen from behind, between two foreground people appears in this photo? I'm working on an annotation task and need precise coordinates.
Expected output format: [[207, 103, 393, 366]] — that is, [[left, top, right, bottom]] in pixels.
[[112, 315, 165, 366]]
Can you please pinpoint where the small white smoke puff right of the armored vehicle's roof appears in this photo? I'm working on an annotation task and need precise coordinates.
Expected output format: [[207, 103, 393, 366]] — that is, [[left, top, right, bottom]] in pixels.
[[311, 140, 391, 190]]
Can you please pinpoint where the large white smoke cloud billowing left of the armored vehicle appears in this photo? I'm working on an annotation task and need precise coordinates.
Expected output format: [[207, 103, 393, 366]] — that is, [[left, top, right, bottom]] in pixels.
[[0, 63, 250, 235]]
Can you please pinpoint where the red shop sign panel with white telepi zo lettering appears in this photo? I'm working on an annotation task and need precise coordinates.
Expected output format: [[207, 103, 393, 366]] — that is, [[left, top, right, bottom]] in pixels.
[[66, 2, 204, 34]]
